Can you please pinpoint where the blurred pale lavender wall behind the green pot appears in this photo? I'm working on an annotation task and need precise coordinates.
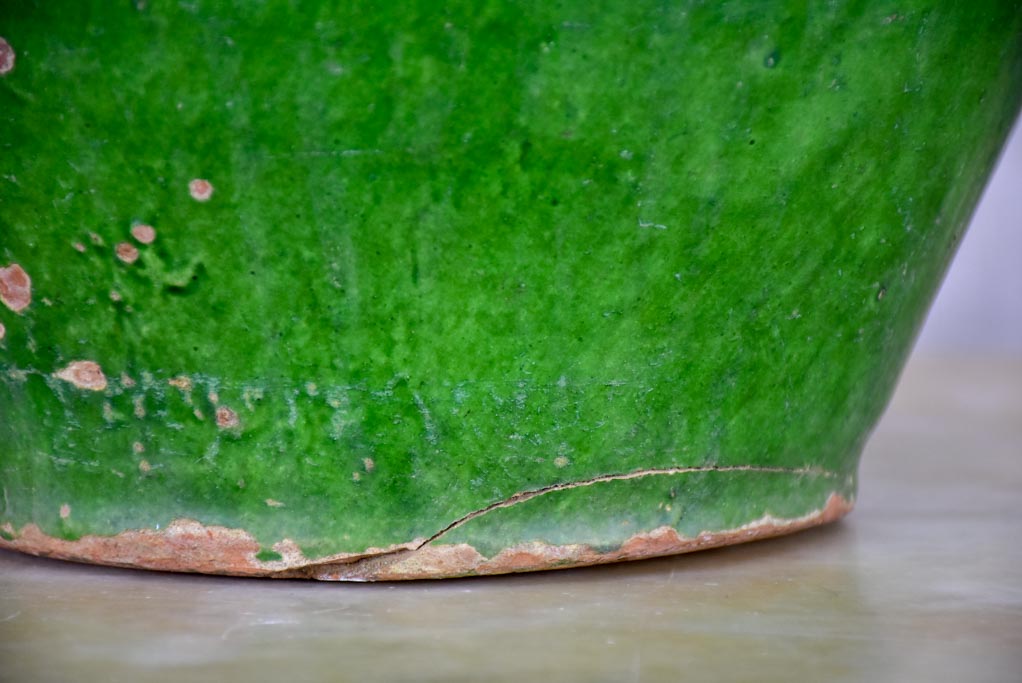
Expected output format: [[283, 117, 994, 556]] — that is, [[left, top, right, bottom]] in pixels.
[[915, 119, 1022, 355]]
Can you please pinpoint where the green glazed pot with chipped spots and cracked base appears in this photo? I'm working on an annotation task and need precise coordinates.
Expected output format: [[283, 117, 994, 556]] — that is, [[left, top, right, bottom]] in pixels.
[[0, 0, 1022, 580]]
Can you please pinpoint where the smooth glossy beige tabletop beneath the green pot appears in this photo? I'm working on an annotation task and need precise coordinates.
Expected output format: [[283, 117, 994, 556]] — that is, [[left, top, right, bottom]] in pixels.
[[0, 358, 1022, 683]]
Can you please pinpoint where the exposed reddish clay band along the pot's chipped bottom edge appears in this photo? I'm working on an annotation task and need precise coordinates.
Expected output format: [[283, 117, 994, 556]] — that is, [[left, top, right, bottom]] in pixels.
[[0, 492, 852, 581]]
